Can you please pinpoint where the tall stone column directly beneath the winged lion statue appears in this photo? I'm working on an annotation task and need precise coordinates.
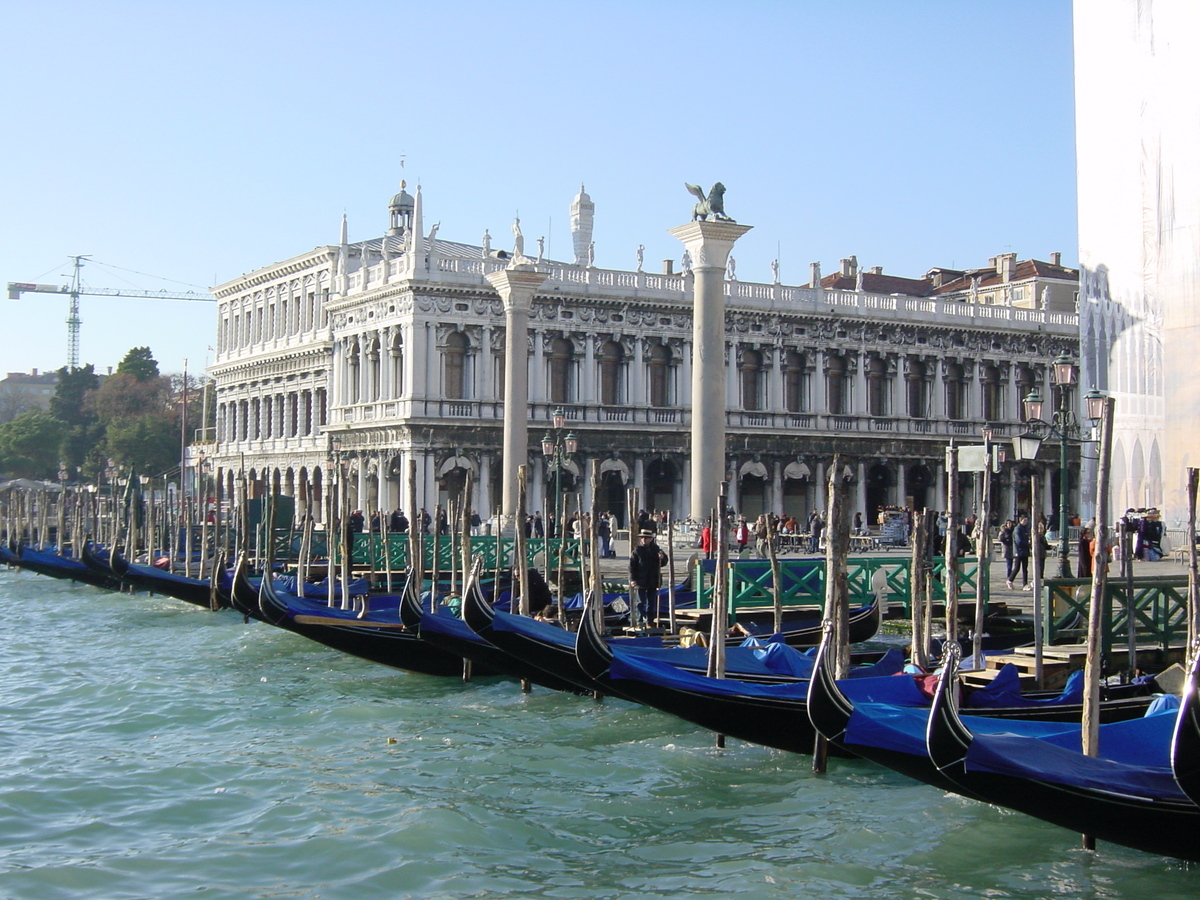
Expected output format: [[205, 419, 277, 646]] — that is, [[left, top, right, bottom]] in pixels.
[[671, 222, 750, 521]]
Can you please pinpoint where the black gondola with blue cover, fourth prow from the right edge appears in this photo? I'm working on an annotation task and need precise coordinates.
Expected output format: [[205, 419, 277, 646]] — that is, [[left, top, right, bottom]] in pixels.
[[575, 602, 904, 754]]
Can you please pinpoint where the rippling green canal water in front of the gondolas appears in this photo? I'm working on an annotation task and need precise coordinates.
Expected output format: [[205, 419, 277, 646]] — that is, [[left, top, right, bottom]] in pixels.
[[0, 570, 1200, 900]]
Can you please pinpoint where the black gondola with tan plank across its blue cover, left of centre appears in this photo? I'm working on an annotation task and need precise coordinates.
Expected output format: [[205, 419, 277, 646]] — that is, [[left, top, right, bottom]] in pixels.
[[258, 566, 480, 676]]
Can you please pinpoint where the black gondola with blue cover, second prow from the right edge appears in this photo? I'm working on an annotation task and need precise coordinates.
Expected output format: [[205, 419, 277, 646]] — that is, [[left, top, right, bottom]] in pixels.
[[926, 654, 1200, 862]]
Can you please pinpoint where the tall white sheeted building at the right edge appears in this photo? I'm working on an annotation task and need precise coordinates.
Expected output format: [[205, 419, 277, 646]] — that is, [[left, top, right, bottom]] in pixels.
[[1074, 0, 1200, 528]]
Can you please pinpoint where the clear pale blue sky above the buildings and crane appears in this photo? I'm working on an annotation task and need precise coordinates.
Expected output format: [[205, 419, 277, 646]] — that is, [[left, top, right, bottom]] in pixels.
[[0, 0, 1078, 377]]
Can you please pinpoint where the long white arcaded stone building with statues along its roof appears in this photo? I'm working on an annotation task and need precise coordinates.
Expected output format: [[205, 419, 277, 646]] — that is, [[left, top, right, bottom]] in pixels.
[[204, 190, 1079, 532]]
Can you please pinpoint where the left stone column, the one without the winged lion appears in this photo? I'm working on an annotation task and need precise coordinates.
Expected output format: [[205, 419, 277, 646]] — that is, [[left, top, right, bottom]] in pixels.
[[486, 265, 546, 528]]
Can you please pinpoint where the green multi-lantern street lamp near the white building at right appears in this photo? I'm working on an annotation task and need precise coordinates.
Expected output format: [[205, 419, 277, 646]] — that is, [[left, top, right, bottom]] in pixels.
[[1013, 356, 1104, 578]]
